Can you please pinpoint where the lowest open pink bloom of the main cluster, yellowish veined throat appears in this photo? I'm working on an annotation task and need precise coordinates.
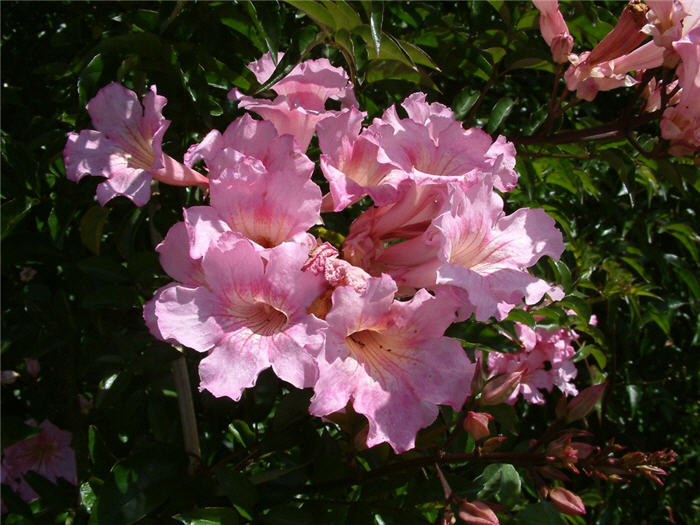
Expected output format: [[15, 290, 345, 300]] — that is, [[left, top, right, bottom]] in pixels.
[[309, 275, 474, 453]]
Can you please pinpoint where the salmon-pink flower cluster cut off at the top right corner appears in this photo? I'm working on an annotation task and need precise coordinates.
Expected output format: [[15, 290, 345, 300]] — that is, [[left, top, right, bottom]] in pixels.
[[533, 0, 700, 156]]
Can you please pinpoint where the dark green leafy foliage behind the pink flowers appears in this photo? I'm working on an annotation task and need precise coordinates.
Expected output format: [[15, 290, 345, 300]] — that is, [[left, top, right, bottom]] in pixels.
[[2, 2, 700, 524]]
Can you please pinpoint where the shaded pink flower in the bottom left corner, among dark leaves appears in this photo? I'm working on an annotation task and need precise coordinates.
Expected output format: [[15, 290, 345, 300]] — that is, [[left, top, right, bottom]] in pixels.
[[2, 419, 78, 501]]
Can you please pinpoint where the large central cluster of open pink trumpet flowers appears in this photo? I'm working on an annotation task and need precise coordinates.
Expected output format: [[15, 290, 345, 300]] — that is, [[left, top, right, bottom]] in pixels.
[[65, 55, 572, 452]]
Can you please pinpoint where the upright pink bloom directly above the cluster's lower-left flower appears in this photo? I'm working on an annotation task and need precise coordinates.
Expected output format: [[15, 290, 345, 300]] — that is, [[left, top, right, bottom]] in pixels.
[[185, 115, 321, 250]]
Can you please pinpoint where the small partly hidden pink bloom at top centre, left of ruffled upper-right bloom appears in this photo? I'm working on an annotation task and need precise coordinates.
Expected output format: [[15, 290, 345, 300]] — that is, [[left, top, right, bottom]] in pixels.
[[317, 107, 403, 211]]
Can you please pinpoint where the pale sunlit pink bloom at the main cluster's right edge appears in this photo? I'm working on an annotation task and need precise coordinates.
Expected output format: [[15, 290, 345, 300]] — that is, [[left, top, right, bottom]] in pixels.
[[432, 182, 564, 321]]
